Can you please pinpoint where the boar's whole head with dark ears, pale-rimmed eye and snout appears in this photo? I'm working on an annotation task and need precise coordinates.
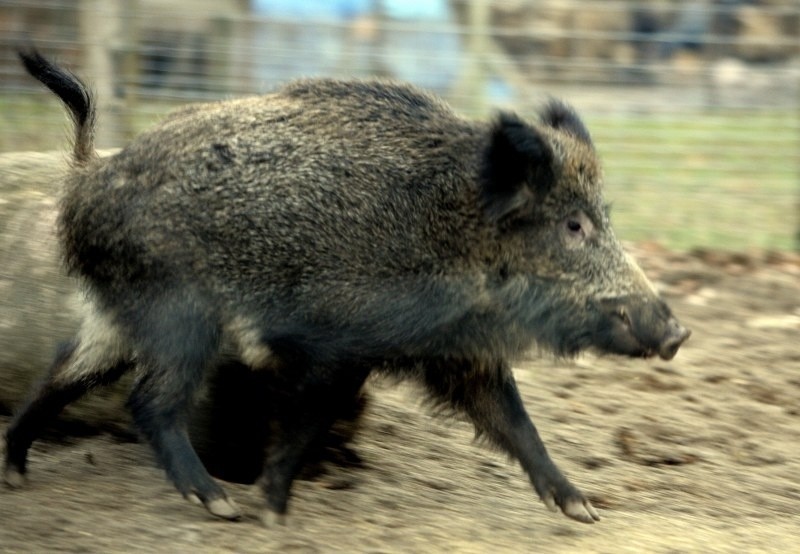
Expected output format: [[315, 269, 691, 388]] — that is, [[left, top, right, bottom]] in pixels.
[[482, 101, 690, 360]]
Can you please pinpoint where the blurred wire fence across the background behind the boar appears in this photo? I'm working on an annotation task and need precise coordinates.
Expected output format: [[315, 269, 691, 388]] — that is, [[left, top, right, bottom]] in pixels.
[[0, 0, 800, 250]]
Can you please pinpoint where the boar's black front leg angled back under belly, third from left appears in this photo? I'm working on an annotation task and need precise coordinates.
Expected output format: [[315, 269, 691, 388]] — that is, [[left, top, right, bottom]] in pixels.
[[261, 360, 370, 527]]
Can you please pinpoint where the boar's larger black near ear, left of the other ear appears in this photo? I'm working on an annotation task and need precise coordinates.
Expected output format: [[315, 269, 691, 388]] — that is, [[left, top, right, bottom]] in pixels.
[[482, 113, 553, 223]]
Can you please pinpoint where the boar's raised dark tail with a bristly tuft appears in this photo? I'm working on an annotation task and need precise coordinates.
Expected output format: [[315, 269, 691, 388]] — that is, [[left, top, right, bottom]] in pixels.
[[19, 48, 95, 165]]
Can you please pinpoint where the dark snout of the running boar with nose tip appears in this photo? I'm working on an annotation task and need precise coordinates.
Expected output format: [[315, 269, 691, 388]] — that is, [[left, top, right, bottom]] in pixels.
[[595, 296, 692, 360]]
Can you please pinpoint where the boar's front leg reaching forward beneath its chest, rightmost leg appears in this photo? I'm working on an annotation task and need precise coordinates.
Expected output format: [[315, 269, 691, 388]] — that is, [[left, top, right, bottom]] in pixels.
[[425, 360, 600, 523]]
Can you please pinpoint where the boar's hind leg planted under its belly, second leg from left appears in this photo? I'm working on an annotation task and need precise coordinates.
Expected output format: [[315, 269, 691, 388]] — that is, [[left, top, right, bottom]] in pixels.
[[128, 298, 240, 519]]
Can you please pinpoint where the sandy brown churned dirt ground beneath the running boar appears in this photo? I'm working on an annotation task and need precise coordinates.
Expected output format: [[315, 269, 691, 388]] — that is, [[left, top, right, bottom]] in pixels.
[[0, 246, 800, 553]]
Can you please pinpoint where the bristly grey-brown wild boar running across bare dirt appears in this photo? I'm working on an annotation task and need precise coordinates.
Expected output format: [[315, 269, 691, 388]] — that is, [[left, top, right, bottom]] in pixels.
[[5, 52, 689, 523]]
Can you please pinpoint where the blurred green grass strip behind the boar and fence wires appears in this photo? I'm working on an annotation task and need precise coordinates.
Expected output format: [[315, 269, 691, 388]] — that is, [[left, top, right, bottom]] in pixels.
[[0, 95, 800, 251]]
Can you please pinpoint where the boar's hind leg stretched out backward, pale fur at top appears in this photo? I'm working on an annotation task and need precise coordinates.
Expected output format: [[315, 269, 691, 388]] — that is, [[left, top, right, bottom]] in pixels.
[[3, 334, 131, 487]]
